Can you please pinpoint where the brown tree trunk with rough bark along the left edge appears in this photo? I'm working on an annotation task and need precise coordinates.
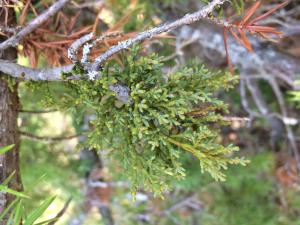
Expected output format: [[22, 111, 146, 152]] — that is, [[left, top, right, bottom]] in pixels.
[[0, 3, 22, 225]]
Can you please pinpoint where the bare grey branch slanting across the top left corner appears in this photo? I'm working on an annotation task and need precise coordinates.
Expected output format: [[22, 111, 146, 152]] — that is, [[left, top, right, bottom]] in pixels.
[[0, 0, 69, 51]]
